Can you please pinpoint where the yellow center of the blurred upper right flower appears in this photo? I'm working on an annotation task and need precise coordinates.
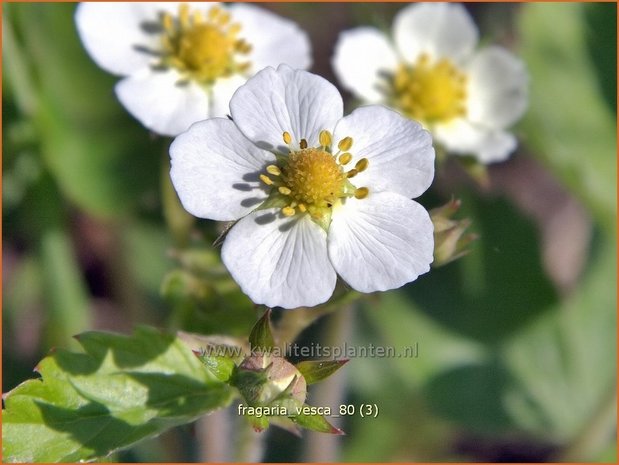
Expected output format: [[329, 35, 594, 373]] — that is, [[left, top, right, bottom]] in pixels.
[[391, 54, 466, 125]]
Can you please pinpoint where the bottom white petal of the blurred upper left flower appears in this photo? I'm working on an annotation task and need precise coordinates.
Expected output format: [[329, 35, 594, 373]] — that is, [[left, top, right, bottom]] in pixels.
[[116, 69, 208, 136]]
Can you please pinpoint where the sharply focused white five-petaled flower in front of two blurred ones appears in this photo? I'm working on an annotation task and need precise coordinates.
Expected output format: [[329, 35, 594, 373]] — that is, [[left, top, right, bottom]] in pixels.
[[170, 65, 434, 308]]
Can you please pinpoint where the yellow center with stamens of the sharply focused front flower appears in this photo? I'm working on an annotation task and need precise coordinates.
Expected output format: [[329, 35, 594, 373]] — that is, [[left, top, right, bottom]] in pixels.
[[260, 130, 369, 229]]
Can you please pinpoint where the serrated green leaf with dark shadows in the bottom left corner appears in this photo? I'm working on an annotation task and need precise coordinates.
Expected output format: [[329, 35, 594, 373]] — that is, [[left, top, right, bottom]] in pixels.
[[2, 328, 234, 462]]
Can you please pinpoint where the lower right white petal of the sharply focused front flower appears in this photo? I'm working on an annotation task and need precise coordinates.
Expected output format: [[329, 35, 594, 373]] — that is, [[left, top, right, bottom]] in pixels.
[[328, 192, 434, 292]]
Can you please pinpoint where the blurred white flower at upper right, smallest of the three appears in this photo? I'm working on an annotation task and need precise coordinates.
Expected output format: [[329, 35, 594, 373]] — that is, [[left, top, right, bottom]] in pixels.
[[333, 3, 527, 163]]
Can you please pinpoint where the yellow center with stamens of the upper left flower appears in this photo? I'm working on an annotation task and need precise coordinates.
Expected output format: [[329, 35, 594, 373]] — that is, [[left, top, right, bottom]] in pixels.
[[161, 3, 251, 84]]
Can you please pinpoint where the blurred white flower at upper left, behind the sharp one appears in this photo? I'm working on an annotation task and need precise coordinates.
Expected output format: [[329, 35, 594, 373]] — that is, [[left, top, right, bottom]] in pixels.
[[75, 2, 311, 136]]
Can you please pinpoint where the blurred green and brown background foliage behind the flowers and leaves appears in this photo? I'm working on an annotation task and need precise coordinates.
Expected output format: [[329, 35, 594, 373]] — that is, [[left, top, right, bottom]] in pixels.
[[2, 3, 617, 463]]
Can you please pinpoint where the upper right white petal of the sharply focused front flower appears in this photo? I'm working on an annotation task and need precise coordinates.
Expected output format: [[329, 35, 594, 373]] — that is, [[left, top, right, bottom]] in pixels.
[[334, 105, 434, 198]]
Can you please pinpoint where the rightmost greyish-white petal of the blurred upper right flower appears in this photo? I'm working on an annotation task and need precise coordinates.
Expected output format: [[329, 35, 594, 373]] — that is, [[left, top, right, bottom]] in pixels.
[[467, 46, 528, 128]]
